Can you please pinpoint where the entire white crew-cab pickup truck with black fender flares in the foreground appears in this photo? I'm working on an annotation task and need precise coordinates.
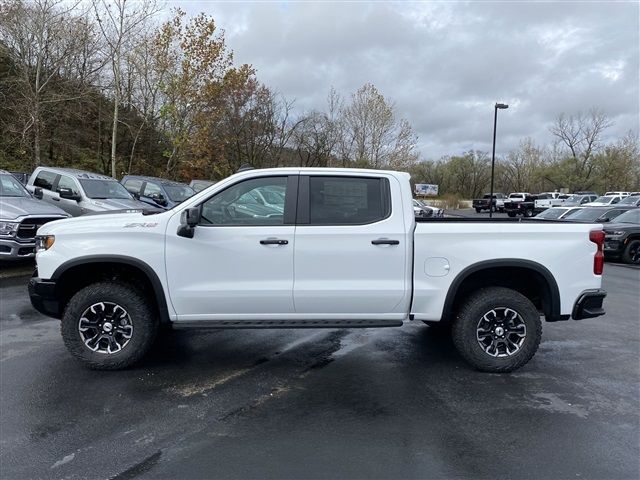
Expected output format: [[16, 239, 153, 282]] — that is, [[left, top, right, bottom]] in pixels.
[[29, 168, 606, 372]]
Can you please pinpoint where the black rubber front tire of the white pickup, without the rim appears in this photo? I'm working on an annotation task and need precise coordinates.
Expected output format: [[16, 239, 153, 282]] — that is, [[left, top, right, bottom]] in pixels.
[[60, 281, 158, 370]]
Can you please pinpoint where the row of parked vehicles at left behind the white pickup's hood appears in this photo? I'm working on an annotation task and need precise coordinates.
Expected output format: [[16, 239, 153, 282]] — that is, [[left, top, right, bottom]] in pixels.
[[0, 167, 218, 260]]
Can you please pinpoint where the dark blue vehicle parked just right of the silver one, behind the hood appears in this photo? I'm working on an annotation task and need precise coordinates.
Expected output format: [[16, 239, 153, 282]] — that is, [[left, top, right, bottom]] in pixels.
[[121, 175, 196, 209]]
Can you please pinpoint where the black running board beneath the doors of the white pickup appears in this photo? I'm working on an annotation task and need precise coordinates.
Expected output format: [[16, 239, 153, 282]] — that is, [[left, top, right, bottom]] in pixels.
[[172, 320, 403, 329]]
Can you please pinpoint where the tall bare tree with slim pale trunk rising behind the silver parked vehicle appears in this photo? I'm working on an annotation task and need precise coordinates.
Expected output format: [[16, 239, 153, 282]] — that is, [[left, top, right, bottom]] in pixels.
[[92, 0, 159, 177]]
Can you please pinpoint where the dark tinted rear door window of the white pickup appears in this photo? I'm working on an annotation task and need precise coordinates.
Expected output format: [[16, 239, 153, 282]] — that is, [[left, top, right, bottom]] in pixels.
[[309, 176, 391, 225]]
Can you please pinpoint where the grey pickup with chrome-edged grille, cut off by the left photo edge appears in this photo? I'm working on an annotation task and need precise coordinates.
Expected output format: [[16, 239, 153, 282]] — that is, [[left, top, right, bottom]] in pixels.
[[0, 170, 69, 260]]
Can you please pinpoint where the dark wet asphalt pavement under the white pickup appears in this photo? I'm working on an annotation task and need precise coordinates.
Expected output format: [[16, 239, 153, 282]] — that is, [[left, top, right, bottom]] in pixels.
[[0, 265, 640, 479]]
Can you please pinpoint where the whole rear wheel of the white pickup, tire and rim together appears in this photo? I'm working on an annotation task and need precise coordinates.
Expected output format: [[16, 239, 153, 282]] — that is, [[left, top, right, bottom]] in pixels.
[[452, 287, 542, 372]]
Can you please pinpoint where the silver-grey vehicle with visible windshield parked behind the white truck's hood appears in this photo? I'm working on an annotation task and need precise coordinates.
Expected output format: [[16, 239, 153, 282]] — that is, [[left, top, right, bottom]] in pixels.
[[27, 167, 148, 217]]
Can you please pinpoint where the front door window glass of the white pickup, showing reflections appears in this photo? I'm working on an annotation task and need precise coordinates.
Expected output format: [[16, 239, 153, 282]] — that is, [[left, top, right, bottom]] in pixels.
[[201, 177, 287, 226]]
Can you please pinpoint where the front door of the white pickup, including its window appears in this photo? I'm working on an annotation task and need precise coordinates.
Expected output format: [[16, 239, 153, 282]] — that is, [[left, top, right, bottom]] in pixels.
[[165, 175, 298, 321]]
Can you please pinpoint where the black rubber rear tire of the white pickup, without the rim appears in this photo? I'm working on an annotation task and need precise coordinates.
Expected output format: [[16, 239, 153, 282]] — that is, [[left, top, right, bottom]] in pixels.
[[451, 287, 542, 373]]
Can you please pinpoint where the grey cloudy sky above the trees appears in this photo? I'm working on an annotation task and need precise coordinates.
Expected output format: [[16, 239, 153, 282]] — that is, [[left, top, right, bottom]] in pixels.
[[169, 1, 640, 158]]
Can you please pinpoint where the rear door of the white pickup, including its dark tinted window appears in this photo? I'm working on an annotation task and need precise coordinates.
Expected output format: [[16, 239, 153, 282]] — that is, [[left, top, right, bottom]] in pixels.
[[293, 174, 413, 320]]
